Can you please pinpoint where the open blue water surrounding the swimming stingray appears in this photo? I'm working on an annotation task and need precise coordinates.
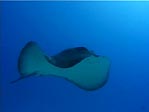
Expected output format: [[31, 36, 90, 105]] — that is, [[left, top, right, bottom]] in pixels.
[[0, 2, 149, 112]]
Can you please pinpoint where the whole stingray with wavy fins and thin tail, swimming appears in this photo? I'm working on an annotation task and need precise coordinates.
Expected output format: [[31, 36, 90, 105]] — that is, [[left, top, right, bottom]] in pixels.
[[13, 41, 110, 91]]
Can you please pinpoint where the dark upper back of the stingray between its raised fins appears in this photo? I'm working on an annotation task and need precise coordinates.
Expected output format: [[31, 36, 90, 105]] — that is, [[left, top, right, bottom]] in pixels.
[[46, 47, 97, 68]]
